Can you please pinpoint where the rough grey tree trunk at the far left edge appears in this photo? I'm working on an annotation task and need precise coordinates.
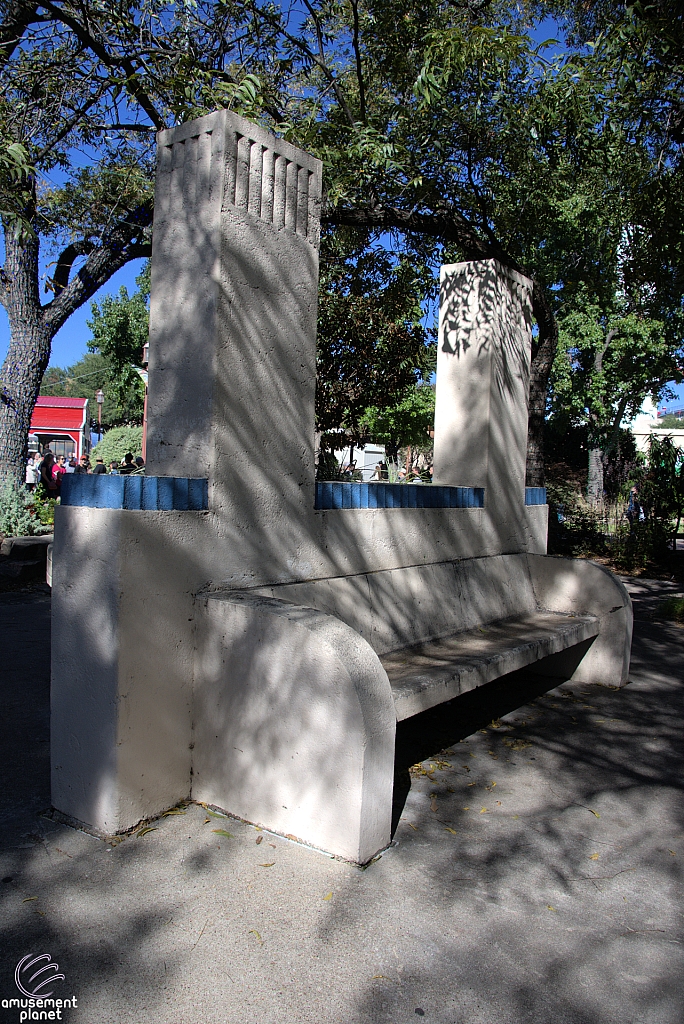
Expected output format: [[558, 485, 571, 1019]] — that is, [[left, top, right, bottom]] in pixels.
[[0, 227, 52, 485]]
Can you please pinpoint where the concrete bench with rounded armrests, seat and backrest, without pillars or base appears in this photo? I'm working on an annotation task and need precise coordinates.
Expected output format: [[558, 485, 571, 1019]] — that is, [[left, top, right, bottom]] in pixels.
[[193, 554, 632, 863]]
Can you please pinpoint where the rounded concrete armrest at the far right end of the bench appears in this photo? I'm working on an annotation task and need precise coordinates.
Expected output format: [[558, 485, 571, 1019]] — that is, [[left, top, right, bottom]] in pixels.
[[527, 555, 634, 686]]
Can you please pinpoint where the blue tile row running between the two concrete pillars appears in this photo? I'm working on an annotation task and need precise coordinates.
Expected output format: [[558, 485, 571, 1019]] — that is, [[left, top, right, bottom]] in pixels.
[[314, 480, 484, 509]]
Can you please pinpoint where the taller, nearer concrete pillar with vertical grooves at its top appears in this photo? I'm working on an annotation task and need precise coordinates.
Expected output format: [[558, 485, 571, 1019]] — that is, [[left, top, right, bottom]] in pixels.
[[147, 111, 320, 543]]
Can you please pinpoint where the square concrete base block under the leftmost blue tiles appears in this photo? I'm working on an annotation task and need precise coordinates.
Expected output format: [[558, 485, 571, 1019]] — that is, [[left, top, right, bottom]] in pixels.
[[51, 508, 202, 834]]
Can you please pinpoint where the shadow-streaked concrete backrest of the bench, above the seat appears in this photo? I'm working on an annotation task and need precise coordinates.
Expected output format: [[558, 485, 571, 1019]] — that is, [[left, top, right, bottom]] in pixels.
[[256, 555, 538, 654]]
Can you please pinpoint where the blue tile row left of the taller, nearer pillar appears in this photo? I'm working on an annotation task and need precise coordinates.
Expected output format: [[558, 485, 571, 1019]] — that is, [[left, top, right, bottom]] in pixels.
[[60, 473, 209, 512]]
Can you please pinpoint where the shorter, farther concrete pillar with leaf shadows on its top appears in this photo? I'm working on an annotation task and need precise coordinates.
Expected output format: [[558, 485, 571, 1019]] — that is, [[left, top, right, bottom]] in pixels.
[[434, 260, 532, 550]]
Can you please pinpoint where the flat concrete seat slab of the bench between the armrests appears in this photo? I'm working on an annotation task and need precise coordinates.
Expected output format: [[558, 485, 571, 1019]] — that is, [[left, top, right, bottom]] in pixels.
[[380, 612, 599, 722]]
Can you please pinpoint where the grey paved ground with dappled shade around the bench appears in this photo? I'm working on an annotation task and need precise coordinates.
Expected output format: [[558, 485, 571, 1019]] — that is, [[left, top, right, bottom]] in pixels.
[[0, 581, 684, 1024]]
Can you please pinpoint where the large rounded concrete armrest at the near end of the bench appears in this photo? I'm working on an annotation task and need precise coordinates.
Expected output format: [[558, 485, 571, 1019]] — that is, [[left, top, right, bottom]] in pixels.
[[193, 595, 395, 863]]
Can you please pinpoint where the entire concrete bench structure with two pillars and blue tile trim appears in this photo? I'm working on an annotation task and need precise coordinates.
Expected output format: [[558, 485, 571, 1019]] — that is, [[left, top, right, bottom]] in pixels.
[[52, 111, 632, 862]]
